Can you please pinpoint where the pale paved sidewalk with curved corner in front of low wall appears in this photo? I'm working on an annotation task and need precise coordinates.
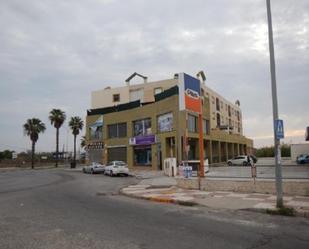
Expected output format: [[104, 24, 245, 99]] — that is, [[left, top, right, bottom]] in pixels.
[[121, 184, 309, 217]]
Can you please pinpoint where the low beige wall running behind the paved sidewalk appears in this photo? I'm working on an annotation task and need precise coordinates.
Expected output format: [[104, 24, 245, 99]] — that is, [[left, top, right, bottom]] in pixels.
[[176, 177, 309, 196]]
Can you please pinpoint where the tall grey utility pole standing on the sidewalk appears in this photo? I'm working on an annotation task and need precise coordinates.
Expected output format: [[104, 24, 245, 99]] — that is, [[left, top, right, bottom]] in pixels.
[[266, 0, 283, 208]]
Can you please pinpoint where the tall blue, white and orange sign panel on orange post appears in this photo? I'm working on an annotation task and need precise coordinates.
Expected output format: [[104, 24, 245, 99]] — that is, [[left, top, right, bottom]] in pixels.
[[179, 73, 202, 113]]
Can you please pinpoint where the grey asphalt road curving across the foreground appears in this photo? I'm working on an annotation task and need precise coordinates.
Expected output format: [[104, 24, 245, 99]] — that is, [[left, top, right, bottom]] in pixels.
[[0, 169, 309, 249]]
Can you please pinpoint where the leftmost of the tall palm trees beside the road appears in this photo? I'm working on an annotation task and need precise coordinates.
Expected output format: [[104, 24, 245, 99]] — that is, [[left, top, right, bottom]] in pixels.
[[23, 118, 46, 169]]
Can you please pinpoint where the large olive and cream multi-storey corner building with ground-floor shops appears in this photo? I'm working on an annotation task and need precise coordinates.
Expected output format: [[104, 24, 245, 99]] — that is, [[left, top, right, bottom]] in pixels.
[[86, 72, 253, 169]]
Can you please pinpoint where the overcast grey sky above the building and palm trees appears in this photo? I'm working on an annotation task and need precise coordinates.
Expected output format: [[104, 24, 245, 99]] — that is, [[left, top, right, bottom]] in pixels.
[[0, 0, 309, 151]]
